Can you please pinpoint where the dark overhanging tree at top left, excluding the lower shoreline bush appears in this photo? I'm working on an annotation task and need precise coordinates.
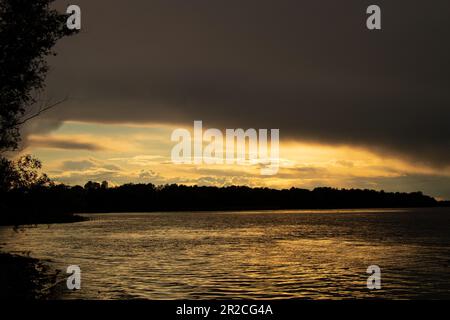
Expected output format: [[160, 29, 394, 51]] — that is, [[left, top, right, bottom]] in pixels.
[[0, 0, 73, 154]]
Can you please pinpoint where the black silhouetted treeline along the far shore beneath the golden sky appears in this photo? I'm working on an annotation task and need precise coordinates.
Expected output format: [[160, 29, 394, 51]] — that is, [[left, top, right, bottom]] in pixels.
[[0, 182, 449, 225]]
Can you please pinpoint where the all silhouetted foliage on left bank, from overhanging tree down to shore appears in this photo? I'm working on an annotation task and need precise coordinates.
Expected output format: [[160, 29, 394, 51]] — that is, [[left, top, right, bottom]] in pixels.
[[0, 0, 76, 224]]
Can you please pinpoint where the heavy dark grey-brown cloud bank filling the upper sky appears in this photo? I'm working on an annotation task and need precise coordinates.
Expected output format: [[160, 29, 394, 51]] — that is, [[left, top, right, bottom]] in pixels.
[[41, 0, 450, 167]]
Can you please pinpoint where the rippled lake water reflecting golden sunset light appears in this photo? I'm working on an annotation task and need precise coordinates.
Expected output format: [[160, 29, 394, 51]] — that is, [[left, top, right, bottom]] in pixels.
[[0, 208, 450, 299]]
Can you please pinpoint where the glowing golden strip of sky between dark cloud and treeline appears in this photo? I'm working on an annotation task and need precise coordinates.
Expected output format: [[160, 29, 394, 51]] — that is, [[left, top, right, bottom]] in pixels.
[[18, 122, 450, 196]]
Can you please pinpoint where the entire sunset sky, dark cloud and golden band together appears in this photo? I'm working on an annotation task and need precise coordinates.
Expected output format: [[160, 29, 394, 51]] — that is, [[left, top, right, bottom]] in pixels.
[[21, 0, 450, 199]]
